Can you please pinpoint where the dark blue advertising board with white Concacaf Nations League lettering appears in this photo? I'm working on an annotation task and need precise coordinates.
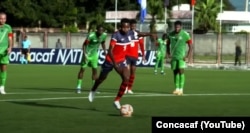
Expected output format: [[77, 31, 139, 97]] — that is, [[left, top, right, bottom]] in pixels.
[[9, 48, 158, 67]]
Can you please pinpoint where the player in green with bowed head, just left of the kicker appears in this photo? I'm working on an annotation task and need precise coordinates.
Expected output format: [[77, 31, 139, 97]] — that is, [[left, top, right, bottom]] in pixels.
[[76, 26, 107, 93]]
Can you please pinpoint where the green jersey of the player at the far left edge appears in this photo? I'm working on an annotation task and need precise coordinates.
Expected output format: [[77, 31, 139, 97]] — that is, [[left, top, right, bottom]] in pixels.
[[0, 24, 12, 54]]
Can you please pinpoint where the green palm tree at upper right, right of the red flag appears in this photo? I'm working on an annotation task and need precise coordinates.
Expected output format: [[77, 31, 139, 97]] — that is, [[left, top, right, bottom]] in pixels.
[[195, 0, 220, 31]]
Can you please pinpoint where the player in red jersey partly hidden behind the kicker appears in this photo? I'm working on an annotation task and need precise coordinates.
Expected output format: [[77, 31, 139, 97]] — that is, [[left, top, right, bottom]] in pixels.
[[126, 19, 145, 94]]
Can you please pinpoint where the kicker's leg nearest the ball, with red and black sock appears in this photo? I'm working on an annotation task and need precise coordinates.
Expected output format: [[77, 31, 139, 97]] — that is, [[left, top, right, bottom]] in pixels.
[[114, 63, 130, 109]]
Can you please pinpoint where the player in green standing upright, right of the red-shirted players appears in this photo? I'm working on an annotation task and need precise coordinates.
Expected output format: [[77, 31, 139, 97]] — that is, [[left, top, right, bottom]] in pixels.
[[167, 21, 192, 95]]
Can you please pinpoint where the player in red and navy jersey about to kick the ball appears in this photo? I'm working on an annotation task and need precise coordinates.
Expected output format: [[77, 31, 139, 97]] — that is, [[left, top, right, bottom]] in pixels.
[[88, 18, 134, 109]]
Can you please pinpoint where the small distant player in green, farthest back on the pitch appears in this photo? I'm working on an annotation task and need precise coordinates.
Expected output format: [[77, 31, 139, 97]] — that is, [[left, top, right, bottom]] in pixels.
[[154, 34, 167, 75]]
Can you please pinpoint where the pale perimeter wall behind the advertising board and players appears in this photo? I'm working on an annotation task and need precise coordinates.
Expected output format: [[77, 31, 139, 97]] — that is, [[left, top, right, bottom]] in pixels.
[[14, 32, 250, 65]]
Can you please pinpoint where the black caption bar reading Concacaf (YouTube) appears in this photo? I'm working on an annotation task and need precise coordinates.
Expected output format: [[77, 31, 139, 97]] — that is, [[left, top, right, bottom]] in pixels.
[[152, 117, 250, 133]]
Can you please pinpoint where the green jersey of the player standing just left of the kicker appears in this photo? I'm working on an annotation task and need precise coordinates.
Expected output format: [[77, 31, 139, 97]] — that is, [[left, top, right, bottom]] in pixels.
[[86, 32, 107, 57]]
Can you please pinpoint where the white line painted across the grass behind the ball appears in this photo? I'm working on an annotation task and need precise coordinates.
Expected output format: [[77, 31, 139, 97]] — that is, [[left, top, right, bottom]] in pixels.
[[0, 93, 250, 102]]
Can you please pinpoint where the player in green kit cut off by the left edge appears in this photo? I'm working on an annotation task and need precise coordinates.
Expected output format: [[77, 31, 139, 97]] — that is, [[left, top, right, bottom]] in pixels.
[[0, 13, 13, 94]]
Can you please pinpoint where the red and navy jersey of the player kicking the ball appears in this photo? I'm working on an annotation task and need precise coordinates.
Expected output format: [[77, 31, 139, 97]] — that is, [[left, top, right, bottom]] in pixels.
[[106, 31, 135, 63]]
